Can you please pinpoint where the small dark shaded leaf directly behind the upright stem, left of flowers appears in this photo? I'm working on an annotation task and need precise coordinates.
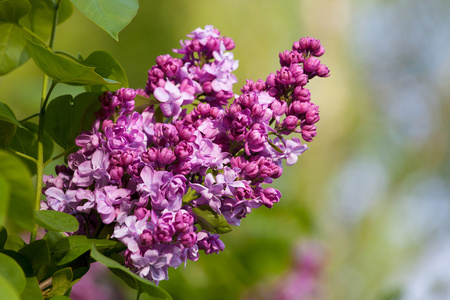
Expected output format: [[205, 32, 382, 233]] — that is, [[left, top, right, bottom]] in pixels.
[[9, 122, 53, 175]]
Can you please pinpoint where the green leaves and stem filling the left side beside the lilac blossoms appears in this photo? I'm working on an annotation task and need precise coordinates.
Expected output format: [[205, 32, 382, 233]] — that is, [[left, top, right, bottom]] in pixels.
[[0, 0, 176, 300]]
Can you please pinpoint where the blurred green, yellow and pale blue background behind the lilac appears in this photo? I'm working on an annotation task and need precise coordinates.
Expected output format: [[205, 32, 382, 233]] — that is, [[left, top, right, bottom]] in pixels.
[[0, 0, 450, 300]]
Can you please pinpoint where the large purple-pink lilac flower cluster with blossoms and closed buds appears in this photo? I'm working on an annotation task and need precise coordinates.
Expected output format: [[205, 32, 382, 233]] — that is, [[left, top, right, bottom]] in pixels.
[[42, 26, 329, 282]]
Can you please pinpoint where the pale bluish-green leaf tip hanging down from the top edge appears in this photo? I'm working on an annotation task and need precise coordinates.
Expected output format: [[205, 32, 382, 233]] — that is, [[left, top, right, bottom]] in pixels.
[[71, 0, 139, 41]]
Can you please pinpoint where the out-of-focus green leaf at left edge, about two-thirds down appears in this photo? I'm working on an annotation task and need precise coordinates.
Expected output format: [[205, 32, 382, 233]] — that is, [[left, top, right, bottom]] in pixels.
[[0, 149, 35, 231]]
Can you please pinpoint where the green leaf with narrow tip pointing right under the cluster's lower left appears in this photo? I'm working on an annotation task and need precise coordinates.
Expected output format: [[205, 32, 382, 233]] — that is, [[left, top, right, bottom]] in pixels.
[[54, 235, 122, 266]]
